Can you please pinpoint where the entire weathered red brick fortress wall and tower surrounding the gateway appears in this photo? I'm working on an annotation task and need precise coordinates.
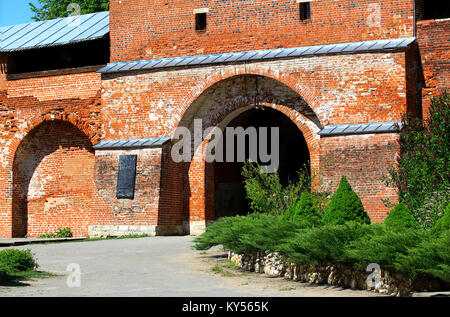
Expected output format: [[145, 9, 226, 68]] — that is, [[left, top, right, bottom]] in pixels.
[[0, 0, 450, 237]]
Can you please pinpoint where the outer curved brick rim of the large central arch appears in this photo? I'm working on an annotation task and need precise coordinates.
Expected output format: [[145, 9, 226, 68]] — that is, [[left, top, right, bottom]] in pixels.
[[175, 65, 323, 131]]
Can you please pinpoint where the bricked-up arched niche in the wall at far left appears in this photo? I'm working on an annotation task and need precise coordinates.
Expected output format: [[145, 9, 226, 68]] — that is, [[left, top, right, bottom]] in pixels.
[[12, 120, 96, 237]]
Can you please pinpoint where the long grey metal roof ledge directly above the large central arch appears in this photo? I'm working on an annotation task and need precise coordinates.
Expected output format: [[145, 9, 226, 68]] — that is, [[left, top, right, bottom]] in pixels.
[[98, 37, 416, 74]]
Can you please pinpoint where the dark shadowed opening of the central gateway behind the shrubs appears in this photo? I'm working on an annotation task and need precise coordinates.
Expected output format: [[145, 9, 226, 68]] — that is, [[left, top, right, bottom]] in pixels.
[[214, 107, 310, 219]]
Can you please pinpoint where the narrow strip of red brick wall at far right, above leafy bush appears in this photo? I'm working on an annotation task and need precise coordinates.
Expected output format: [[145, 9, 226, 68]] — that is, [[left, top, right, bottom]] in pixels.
[[417, 19, 450, 117]]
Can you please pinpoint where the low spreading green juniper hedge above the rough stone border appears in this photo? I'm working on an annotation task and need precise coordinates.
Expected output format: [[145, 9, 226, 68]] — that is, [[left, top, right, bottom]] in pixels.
[[194, 214, 450, 281]]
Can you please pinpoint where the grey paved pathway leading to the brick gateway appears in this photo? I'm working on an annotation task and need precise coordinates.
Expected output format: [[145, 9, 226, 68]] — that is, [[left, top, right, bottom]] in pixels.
[[0, 237, 384, 297]]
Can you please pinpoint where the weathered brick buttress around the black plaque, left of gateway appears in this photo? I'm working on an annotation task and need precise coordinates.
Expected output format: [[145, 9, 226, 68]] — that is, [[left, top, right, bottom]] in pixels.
[[91, 148, 183, 234]]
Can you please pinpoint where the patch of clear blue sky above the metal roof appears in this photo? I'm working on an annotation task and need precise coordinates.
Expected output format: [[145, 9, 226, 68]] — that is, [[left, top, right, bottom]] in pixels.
[[0, 0, 38, 26]]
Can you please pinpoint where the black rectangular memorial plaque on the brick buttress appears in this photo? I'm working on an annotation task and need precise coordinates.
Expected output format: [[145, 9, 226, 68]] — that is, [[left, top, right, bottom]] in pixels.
[[116, 155, 137, 199]]
